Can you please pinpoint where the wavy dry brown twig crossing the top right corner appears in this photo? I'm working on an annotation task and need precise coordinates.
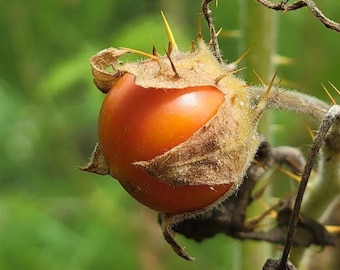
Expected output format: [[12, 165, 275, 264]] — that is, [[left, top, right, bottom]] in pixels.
[[256, 0, 340, 32]]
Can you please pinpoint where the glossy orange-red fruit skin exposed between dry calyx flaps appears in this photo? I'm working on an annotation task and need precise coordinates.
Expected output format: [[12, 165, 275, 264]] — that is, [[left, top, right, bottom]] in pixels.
[[98, 73, 231, 214]]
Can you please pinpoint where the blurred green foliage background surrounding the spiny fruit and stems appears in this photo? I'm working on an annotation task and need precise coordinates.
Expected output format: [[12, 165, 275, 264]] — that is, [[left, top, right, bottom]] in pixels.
[[0, 0, 340, 270]]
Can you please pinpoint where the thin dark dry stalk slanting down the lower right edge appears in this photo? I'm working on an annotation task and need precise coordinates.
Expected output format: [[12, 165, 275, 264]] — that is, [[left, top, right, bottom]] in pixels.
[[279, 105, 339, 270]]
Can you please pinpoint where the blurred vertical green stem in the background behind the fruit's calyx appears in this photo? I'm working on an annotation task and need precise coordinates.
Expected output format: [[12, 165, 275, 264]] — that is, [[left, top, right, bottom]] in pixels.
[[239, 0, 278, 269]]
